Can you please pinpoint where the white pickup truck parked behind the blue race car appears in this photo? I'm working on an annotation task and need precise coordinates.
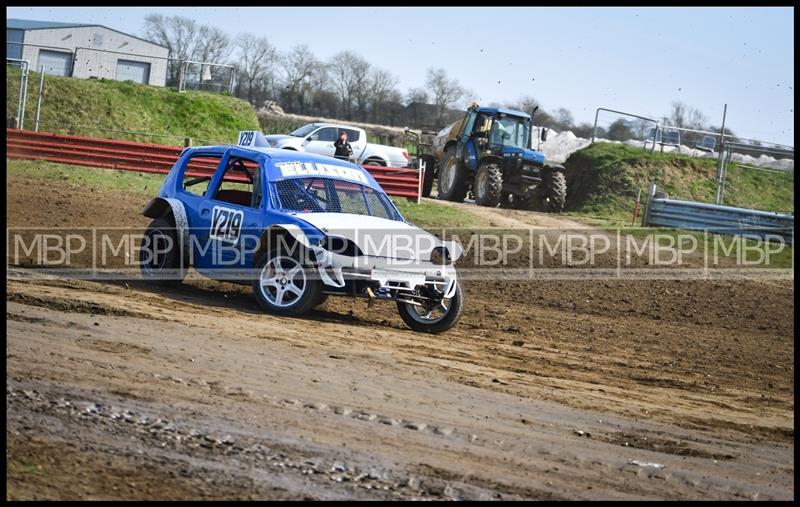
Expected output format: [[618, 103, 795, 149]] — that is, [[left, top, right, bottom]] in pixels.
[[264, 123, 409, 167]]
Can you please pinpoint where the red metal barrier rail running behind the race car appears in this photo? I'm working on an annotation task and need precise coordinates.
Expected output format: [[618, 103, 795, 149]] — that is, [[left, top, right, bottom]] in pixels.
[[6, 128, 420, 199]]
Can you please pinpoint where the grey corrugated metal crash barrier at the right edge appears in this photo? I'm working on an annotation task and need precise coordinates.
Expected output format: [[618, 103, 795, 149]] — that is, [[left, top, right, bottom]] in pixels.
[[642, 184, 794, 244]]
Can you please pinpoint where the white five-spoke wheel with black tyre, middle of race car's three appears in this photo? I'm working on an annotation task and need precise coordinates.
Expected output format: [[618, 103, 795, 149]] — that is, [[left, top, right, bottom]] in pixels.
[[253, 247, 322, 315]]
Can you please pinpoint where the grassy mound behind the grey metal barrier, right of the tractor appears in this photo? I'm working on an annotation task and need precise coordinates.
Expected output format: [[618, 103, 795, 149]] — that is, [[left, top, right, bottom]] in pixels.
[[564, 143, 794, 226]]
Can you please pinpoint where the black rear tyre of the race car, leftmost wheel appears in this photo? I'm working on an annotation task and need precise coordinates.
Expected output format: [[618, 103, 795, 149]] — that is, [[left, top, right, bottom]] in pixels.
[[139, 215, 186, 287]]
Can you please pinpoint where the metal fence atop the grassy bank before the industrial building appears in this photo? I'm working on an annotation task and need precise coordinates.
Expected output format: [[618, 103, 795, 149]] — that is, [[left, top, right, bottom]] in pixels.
[[6, 41, 236, 93]]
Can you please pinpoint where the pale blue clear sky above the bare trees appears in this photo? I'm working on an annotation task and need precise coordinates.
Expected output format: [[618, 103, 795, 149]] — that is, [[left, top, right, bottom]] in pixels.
[[6, 6, 794, 146]]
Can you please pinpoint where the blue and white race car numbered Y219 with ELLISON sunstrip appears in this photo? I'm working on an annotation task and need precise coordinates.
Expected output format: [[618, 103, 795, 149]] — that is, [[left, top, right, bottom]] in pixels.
[[140, 131, 464, 333]]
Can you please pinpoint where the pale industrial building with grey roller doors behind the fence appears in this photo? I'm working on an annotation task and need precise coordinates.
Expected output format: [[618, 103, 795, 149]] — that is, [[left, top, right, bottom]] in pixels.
[[6, 19, 169, 86]]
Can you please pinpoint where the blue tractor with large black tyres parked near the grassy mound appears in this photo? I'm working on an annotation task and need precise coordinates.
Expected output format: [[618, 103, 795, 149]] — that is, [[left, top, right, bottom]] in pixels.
[[426, 103, 567, 212]]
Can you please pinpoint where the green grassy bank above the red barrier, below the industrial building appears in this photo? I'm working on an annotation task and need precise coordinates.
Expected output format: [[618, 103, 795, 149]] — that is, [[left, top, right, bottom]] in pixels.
[[6, 66, 258, 145]]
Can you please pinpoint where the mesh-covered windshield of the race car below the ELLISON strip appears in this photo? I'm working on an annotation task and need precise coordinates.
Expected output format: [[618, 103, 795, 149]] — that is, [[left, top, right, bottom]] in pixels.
[[272, 178, 403, 221]]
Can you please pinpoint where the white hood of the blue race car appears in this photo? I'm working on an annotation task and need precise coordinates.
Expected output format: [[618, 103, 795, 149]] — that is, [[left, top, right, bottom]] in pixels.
[[298, 213, 461, 261]]
